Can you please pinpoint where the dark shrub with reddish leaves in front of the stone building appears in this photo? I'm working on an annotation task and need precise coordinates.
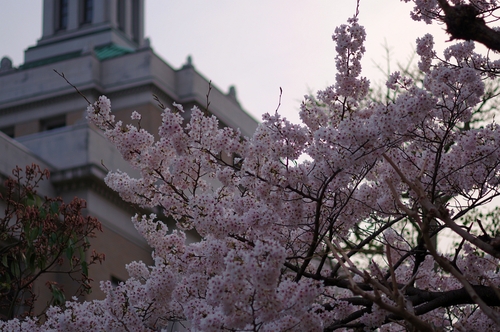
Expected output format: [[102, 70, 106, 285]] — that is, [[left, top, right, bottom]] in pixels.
[[0, 164, 104, 319]]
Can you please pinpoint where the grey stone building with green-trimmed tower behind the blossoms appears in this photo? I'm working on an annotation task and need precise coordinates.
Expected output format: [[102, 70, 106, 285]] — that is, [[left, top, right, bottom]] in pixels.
[[0, 0, 257, 314]]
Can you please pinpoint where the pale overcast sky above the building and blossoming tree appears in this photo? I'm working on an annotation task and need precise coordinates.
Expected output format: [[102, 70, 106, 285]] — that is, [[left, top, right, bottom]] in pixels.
[[0, 0, 447, 122]]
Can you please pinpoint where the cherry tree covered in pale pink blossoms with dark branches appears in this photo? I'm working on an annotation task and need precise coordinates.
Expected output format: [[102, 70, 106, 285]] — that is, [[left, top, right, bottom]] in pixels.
[[4, 0, 500, 331]]
